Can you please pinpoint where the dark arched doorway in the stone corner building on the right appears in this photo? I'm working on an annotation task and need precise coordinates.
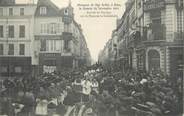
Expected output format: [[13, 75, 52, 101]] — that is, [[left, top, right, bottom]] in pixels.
[[148, 50, 160, 71]]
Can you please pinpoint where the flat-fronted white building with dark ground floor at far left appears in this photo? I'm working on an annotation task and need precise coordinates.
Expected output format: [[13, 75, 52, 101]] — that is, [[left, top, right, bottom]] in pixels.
[[0, 0, 36, 77]]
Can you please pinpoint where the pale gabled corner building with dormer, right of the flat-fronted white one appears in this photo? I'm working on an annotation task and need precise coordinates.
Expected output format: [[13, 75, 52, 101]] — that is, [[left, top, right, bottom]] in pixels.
[[34, 0, 91, 72]]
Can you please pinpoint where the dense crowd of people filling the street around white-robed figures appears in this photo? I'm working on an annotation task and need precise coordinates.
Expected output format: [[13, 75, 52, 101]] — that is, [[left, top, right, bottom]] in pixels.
[[0, 65, 183, 116]]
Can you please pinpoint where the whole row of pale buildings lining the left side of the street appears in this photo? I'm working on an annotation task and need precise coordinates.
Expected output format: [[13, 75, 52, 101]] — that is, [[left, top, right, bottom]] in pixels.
[[0, 0, 91, 77]]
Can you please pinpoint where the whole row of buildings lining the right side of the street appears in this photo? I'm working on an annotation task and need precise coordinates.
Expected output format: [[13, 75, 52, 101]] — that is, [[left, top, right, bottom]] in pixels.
[[99, 0, 184, 77]]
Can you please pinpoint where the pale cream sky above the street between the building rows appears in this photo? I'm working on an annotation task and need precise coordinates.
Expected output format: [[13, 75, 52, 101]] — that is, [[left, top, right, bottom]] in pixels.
[[16, 0, 126, 61]]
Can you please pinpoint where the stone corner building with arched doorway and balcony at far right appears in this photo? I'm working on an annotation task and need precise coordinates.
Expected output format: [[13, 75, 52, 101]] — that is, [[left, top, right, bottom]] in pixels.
[[143, 0, 184, 77]]
